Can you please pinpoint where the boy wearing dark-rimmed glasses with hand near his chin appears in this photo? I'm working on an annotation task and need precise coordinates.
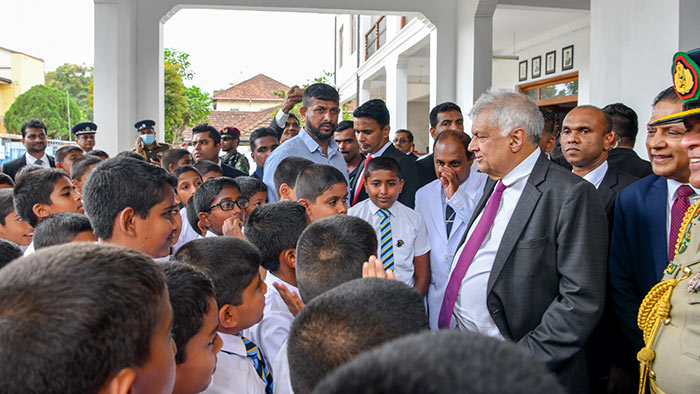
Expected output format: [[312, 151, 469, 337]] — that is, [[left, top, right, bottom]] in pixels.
[[192, 177, 248, 239]]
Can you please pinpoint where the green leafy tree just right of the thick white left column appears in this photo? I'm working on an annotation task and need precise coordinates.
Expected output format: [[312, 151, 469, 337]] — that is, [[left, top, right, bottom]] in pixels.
[[164, 48, 212, 143]]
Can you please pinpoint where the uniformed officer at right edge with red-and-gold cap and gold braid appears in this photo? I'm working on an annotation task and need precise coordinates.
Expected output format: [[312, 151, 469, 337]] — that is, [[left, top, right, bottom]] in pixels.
[[637, 49, 700, 394]]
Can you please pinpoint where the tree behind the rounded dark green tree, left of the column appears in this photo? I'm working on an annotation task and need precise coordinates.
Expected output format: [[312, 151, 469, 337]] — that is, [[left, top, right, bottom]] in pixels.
[[46, 63, 93, 120]]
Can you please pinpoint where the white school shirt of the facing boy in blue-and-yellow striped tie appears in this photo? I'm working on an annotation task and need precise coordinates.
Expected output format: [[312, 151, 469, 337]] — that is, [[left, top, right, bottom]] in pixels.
[[348, 198, 430, 286]]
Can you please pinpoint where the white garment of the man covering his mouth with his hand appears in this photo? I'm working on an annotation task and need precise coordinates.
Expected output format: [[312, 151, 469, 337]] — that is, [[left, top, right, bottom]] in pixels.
[[416, 168, 488, 329]]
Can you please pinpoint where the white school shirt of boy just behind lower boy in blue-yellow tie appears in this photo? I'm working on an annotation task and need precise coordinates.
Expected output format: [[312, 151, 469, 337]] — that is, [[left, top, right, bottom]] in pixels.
[[243, 272, 299, 373]]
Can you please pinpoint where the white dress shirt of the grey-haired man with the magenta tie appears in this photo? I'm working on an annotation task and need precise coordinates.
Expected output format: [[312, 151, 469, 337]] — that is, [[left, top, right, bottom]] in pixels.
[[450, 148, 541, 339]]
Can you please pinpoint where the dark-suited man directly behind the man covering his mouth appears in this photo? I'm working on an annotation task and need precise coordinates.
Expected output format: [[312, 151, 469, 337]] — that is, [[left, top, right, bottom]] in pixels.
[[416, 101, 464, 187]]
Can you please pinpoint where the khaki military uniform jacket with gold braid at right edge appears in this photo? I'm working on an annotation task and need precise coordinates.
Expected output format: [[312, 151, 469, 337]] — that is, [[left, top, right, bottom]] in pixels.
[[640, 202, 700, 394]]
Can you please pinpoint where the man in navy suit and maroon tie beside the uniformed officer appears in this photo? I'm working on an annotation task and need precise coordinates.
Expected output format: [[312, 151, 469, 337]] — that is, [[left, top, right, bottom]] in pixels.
[[610, 88, 696, 354]]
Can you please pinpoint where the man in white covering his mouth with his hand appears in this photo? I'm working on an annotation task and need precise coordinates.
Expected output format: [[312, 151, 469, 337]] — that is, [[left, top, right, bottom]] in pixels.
[[416, 130, 488, 329]]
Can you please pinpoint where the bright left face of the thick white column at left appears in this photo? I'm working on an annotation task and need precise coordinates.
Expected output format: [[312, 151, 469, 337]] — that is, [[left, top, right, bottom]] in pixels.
[[94, 0, 135, 155]]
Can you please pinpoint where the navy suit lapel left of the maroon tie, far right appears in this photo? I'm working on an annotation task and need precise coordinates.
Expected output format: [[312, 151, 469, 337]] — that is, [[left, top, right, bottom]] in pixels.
[[646, 177, 669, 280]]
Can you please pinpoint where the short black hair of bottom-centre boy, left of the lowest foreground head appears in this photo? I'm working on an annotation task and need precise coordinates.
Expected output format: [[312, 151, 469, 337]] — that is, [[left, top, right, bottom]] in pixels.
[[287, 278, 428, 394]]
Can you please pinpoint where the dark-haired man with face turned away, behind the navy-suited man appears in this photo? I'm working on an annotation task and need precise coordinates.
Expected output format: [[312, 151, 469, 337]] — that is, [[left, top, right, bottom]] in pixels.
[[603, 103, 652, 178]]
